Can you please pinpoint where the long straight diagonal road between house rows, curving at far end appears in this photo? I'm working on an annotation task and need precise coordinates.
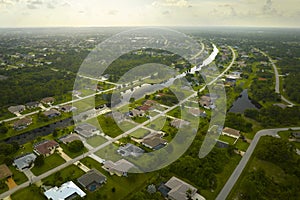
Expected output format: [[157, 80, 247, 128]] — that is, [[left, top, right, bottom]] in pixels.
[[0, 43, 236, 199]]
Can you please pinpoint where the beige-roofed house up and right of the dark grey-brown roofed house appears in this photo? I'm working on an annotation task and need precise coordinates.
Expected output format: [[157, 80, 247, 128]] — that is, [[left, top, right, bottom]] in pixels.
[[102, 159, 135, 176]]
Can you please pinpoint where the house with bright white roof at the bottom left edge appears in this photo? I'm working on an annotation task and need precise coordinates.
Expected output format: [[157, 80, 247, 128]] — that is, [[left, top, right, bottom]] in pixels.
[[44, 181, 86, 200]]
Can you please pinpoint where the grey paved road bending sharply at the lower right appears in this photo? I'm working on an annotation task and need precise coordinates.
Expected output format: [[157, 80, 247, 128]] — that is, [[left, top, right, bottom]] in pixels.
[[216, 127, 300, 200]]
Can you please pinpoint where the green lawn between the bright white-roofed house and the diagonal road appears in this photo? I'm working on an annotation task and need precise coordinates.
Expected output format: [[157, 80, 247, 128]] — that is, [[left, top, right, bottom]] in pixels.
[[42, 165, 84, 186]]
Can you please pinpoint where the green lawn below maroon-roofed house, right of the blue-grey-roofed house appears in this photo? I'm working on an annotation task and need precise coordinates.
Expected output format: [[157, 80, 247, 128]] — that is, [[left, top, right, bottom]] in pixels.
[[31, 153, 65, 176]]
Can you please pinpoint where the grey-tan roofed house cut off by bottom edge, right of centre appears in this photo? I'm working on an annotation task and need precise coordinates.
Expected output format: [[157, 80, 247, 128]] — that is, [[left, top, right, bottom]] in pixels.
[[158, 176, 205, 200]]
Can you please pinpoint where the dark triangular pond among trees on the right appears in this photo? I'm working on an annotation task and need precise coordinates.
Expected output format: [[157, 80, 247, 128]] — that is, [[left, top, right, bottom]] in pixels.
[[229, 89, 260, 113]]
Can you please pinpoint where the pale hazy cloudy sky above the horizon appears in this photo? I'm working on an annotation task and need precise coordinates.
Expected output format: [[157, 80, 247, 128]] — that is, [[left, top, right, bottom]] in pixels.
[[0, 0, 300, 27]]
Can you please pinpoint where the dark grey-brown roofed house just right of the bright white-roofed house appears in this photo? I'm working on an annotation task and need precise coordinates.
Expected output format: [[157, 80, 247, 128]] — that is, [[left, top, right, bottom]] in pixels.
[[77, 169, 106, 192]]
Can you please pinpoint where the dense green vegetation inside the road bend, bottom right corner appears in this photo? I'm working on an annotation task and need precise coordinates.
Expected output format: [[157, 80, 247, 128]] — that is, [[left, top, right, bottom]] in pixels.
[[229, 136, 300, 199]]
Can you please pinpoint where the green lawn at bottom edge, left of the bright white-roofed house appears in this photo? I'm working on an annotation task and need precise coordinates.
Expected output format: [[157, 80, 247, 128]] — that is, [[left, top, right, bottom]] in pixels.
[[11, 185, 46, 200]]
